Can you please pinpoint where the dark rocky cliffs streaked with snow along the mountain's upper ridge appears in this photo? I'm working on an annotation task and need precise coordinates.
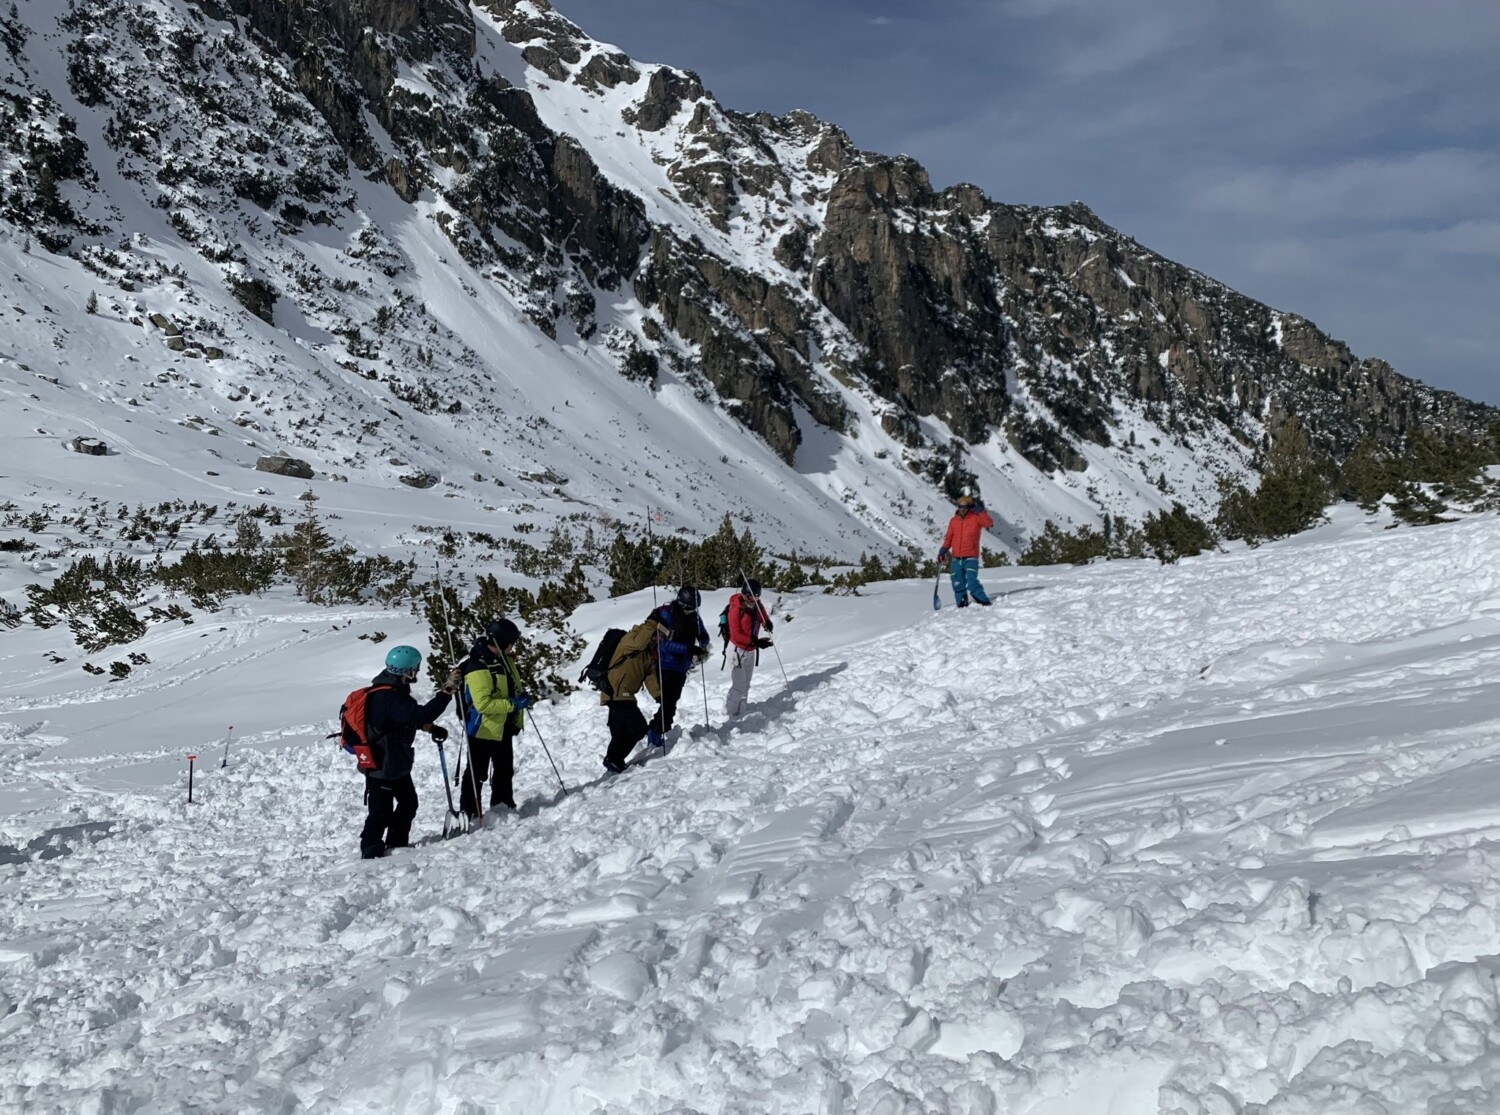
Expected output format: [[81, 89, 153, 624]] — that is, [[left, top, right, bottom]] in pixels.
[[0, 0, 1494, 546]]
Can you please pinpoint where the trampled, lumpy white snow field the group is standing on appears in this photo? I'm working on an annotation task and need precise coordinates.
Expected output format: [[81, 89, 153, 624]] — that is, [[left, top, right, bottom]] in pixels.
[[0, 518, 1500, 1115]]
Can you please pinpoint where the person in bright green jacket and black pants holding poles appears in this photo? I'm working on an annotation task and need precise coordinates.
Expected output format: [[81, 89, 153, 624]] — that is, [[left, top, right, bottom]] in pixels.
[[459, 618, 534, 818]]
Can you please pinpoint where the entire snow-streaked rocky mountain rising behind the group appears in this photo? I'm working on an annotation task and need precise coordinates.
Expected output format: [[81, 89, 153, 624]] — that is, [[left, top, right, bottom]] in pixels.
[[0, 0, 1488, 576]]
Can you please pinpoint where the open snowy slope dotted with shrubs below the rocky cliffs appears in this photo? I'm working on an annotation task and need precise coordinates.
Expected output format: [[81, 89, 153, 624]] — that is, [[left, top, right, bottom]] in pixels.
[[0, 5, 938, 552]]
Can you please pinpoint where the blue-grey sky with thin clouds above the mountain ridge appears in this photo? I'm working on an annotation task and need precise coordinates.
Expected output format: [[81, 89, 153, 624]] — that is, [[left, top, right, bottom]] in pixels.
[[555, 0, 1500, 404]]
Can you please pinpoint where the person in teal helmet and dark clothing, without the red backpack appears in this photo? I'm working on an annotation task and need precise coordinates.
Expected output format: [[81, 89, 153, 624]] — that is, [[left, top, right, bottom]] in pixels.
[[360, 647, 462, 860]]
